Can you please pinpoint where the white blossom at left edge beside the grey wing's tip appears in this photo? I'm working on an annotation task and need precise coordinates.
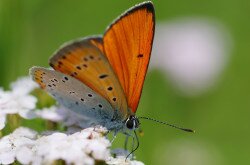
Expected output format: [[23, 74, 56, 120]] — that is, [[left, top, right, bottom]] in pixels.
[[0, 77, 37, 129]]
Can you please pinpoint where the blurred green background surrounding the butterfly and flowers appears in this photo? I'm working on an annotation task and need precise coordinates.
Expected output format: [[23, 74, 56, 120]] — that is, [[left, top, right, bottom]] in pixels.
[[0, 0, 250, 165]]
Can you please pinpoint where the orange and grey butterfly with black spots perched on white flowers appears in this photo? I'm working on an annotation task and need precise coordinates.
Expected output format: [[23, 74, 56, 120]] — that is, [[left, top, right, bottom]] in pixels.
[[30, 2, 155, 135]]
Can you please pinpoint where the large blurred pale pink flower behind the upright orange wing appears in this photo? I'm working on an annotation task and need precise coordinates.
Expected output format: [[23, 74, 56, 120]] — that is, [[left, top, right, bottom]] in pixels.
[[151, 19, 231, 95]]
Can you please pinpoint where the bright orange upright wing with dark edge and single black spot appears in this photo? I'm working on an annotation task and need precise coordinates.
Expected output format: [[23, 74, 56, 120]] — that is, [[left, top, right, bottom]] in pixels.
[[103, 2, 155, 112]]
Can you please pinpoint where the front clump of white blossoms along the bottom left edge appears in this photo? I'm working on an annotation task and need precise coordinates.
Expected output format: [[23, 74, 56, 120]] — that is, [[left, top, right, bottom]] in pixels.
[[0, 127, 110, 165]]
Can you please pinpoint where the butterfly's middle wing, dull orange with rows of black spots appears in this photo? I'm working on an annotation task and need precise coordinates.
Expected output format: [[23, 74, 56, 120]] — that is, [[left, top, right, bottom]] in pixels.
[[50, 37, 128, 117]]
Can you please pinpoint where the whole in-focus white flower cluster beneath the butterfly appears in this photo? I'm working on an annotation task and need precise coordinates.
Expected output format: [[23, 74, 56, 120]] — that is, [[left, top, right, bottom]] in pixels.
[[0, 77, 143, 165]]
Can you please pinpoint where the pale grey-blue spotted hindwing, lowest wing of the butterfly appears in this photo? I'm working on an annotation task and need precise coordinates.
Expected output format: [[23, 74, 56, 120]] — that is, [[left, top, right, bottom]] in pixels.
[[30, 67, 114, 121]]
